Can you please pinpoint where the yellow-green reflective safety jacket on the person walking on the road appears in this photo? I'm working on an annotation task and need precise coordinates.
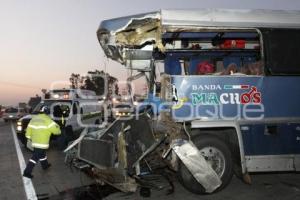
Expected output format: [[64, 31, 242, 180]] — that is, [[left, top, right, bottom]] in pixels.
[[26, 114, 61, 149]]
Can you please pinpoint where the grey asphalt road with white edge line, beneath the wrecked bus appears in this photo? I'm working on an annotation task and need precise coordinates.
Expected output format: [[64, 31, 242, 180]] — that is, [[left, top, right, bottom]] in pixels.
[[0, 119, 300, 200]]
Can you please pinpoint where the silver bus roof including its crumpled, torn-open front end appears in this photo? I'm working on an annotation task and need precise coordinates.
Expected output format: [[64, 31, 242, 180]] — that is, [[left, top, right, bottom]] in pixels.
[[97, 9, 300, 64]]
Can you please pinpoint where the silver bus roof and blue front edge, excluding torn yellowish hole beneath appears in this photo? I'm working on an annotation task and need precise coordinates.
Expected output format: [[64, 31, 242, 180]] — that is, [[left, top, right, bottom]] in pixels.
[[98, 8, 300, 32]]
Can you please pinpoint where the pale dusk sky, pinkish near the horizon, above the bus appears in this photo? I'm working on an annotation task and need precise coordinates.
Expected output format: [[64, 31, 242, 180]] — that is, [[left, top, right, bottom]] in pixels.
[[0, 0, 300, 105]]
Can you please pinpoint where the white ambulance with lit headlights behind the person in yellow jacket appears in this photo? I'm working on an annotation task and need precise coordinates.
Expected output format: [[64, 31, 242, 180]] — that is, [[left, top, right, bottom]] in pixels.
[[17, 89, 103, 145]]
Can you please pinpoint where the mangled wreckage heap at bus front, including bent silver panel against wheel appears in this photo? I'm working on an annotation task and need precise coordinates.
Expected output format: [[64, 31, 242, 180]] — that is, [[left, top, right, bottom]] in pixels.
[[65, 113, 221, 193]]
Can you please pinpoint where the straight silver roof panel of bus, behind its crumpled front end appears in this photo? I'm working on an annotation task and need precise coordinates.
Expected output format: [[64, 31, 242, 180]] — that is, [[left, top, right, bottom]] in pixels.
[[161, 9, 300, 28]]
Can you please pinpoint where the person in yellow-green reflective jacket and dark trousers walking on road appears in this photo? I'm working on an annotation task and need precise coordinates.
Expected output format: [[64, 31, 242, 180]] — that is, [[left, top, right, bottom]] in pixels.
[[23, 106, 61, 178]]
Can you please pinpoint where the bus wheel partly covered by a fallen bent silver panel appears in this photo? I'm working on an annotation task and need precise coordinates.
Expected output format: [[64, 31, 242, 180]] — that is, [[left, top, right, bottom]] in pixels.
[[178, 135, 233, 194]]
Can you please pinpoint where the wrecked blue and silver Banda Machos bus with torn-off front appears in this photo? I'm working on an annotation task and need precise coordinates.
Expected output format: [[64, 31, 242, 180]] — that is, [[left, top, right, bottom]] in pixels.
[[67, 9, 300, 194]]
